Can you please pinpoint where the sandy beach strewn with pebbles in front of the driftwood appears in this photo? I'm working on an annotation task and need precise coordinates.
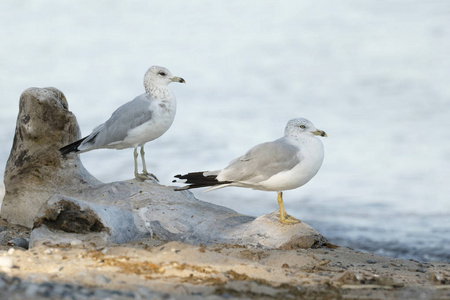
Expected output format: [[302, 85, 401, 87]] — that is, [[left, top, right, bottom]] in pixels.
[[0, 221, 450, 299]]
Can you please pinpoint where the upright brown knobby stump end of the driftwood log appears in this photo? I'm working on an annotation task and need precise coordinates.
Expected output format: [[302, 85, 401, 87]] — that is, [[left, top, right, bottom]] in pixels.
[[1, 87, 100, 227]]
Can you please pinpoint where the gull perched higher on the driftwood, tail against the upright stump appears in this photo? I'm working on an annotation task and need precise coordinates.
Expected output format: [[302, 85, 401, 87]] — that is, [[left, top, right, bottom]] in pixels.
[[59, 66, 185, 181]]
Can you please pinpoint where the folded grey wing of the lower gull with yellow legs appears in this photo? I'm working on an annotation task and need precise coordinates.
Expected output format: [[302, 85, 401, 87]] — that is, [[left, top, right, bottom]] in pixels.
[[217, 138, 300, 183]]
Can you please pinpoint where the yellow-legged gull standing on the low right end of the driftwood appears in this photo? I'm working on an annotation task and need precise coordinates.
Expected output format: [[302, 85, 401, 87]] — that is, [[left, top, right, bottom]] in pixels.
[[173, 118, 327, 224]]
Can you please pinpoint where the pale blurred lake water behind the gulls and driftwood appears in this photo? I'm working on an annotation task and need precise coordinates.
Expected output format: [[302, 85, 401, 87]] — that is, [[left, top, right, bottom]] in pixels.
[[0, 0, 450, 261]]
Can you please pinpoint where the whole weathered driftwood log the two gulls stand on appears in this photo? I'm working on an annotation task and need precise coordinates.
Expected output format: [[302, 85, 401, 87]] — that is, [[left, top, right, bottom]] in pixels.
[[1, 88, 326, 249]]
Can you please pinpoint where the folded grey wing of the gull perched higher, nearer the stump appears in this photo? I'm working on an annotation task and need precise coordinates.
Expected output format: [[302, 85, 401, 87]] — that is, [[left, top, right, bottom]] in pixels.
[[80, 94, 153, 150]]
